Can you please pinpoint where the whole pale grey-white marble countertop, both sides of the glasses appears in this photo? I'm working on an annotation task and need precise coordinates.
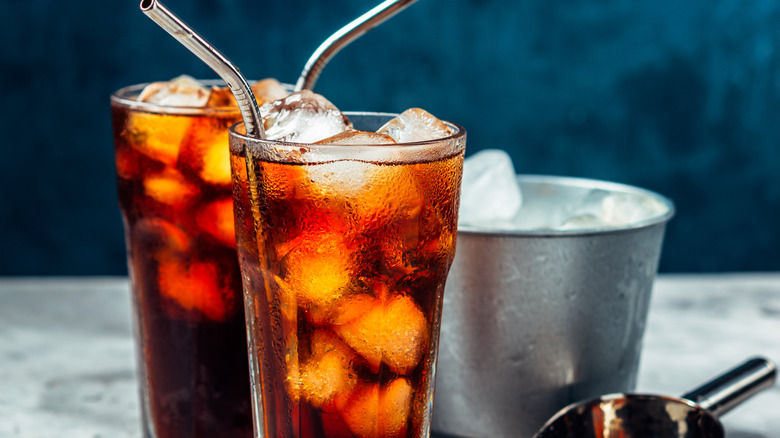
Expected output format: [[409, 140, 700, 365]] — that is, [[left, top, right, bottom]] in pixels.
[[0, 273, 780, 438]]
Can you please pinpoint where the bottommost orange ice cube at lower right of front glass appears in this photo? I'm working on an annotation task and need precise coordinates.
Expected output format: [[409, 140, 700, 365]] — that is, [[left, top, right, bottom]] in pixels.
[[342, 377, 412, 438]]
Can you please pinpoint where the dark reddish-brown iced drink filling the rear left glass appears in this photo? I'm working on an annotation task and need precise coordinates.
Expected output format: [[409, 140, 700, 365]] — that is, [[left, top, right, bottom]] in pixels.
[[112, 104, 252, 438]]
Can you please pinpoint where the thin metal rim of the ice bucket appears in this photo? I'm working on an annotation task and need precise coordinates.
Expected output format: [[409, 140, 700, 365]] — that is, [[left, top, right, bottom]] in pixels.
[[458, 174, 675, 237]]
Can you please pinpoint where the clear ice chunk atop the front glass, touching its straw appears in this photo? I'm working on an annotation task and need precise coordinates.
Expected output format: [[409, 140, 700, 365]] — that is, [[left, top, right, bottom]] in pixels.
[[260, 90, 352, 143]]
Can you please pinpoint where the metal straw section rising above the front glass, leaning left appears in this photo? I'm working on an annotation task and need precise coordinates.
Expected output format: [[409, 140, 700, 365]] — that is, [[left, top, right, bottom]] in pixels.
[[141, 0, 265, 138]]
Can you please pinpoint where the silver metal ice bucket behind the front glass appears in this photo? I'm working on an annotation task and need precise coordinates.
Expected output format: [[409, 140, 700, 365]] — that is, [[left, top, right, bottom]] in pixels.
[[432, 176, 674, 438]]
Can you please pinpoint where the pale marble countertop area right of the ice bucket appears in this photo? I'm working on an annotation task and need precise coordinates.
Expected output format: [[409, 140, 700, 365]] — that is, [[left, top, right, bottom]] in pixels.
[[638, 274, 780, 438]]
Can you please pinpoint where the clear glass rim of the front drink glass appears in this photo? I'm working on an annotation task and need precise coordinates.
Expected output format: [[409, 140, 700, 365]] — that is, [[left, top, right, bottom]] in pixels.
[[228, 111, 466, 152]]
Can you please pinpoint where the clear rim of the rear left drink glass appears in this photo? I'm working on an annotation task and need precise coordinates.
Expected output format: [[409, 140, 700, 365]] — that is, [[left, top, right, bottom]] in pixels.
[[111, 79, 256, 116]]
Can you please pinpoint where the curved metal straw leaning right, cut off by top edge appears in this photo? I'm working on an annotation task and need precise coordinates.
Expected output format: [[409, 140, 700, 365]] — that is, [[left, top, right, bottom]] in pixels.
[[295, 0, 417, 91]]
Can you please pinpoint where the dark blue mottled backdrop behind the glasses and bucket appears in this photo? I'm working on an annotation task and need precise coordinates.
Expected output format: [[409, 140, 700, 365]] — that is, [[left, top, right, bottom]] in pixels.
[[0, 0, 780, 275]]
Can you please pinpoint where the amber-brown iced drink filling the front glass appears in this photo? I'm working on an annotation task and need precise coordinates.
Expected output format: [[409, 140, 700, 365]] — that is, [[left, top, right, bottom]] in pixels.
[[232, 148, 463, 438]]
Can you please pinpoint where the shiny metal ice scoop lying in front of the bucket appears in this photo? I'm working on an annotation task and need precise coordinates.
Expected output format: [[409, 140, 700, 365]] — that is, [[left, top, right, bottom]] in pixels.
[[534, 358, 777, 438]]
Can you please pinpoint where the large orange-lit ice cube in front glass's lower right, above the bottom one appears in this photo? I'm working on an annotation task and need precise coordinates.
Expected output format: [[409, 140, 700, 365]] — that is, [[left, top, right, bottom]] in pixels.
[[335, 295, 429, 374]]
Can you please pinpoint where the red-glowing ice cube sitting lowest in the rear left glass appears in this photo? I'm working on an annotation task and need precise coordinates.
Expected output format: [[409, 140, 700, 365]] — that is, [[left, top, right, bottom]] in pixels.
[[158, 259, 235, 321]]
